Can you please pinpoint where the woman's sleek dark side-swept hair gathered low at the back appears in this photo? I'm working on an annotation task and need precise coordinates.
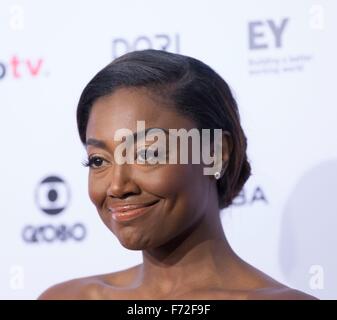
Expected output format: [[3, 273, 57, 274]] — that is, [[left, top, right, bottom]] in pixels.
[[77, 50, 250, 208]]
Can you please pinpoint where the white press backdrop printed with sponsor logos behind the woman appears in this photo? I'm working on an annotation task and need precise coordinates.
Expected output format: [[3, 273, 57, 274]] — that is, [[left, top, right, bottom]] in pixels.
[[0, 0, 337, 299]]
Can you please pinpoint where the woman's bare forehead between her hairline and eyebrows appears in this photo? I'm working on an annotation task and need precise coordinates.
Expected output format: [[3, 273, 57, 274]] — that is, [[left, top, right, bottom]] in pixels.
[[86, 88, 196, 140]]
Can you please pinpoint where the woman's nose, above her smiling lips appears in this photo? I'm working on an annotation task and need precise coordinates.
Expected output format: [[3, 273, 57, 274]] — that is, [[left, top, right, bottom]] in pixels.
[[107, 164, 141, 199]]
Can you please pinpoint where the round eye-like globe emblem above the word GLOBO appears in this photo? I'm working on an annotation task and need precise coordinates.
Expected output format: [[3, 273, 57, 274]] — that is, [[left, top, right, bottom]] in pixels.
[[35, 176, 70, 215]]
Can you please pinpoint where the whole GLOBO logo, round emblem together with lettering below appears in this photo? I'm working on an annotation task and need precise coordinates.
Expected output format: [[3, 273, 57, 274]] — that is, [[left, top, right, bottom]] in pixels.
[[22, 175, 87, 244]]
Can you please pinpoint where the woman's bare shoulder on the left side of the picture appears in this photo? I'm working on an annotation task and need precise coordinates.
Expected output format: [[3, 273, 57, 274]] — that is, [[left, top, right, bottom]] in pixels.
[[38, 266, 137, 300]]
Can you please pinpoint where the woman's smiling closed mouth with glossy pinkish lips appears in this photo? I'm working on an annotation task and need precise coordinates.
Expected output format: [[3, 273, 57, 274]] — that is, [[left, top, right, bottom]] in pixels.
[[108, 200, 159, 222]]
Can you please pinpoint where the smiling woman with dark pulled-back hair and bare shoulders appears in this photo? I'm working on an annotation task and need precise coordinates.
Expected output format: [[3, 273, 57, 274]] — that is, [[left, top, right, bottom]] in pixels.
[[40, 50, 313, 299]]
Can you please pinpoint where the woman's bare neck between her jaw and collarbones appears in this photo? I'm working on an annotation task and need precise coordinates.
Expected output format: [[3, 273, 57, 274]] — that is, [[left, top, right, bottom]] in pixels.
[[138, 212, 235, 295]]
